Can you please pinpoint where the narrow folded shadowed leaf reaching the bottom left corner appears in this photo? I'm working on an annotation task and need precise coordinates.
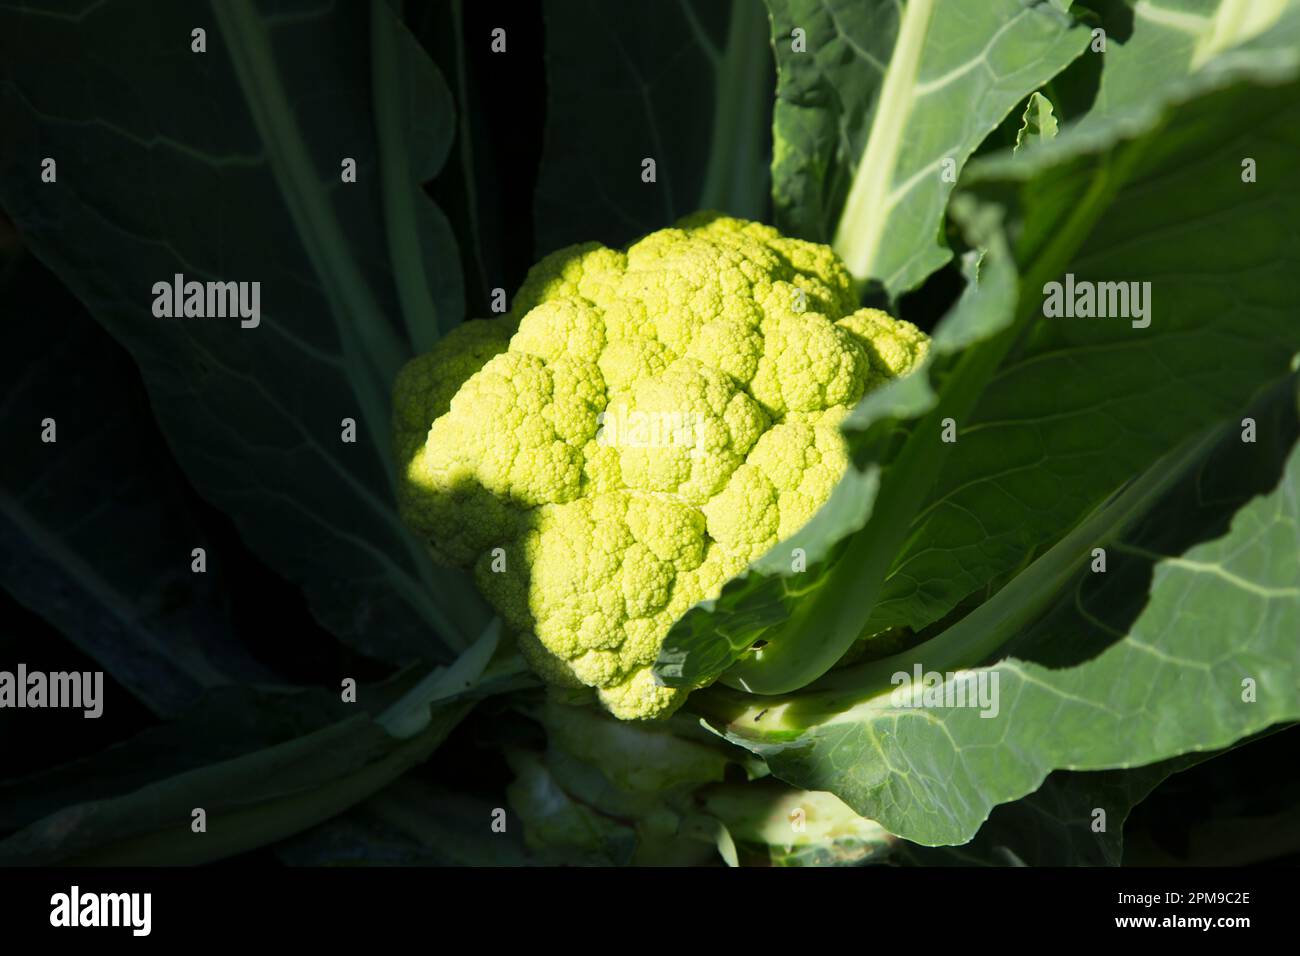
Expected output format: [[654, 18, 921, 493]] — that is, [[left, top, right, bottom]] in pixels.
[[0, 630, 497, 865]]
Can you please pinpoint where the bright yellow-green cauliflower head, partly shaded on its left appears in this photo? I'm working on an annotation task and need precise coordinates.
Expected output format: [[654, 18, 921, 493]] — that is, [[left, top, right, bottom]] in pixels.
[[394, 213, 928, 719]]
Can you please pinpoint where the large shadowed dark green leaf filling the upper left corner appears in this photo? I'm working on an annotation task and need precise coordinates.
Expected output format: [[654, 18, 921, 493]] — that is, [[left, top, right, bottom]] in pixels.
[[0, 0, 488, 661]]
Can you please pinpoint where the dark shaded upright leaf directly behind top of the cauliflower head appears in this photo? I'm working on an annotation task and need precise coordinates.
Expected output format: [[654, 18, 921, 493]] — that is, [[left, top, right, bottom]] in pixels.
[[536, 0, 772, 252]]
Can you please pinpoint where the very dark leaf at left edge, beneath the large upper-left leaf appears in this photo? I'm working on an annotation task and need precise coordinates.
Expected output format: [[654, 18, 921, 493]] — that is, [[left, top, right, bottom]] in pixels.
[[0, 255, 272, 715]]
